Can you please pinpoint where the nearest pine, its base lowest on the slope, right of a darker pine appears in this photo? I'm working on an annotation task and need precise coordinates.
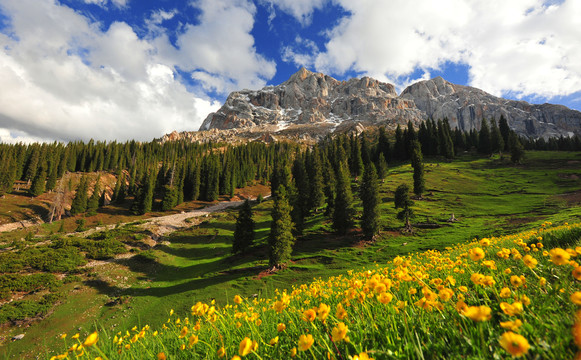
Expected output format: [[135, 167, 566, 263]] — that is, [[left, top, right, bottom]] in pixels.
[[268, 186, 295, 268]]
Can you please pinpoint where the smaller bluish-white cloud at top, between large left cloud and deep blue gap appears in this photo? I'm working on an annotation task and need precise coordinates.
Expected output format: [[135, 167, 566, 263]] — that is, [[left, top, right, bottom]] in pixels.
[[158, 0, 276, 94]]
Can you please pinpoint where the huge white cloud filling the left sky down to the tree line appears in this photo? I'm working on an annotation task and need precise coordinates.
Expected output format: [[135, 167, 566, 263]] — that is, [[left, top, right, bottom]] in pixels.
[[0, 0, 219, 141]]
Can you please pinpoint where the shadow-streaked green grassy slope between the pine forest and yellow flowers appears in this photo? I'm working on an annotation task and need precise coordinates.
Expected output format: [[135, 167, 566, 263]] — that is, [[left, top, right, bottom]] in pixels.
[[5, 152, 581, 358]]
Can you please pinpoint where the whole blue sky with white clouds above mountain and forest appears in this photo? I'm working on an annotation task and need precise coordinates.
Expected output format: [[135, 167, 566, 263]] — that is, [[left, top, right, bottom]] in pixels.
[[0, 0, 581, 142]]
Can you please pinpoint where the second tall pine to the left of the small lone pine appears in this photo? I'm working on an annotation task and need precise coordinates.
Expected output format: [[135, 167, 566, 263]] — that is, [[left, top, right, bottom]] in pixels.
[[333, 163, 355, 235]]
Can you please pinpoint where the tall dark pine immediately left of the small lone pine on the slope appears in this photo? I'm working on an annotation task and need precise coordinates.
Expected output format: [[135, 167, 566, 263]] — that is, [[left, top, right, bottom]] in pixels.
[[359, 163, 379, 239]]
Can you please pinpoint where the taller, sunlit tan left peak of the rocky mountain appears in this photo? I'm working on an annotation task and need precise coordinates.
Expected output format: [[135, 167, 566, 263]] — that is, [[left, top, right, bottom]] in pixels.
[[200, 68, 425, 130]]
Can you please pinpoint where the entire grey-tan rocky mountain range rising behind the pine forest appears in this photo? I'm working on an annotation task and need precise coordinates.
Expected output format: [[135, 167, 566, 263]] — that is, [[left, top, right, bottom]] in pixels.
[[200, 68, 581, 138]]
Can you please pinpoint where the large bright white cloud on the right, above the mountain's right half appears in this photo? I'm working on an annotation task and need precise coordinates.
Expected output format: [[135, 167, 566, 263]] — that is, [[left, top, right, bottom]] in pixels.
[[300, 0, 581, 97]]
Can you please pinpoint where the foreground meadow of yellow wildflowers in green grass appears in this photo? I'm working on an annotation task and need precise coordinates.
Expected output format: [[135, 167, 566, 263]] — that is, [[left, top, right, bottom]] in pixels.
[[51, 223, 581, 360]]
